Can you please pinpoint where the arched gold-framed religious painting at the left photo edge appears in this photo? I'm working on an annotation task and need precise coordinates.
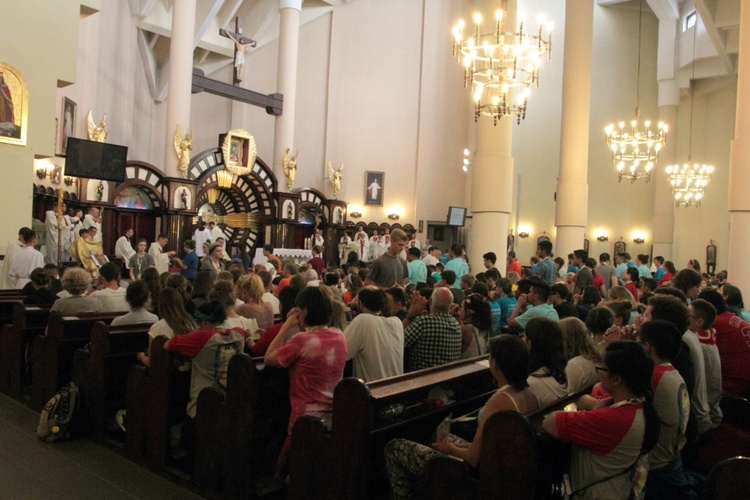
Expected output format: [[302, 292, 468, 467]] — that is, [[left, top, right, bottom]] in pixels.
[[0, 62, 29, 146]]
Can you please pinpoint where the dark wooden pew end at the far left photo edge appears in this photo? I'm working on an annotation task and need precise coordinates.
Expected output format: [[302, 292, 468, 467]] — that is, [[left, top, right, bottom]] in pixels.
[[0, 302, 49, 398]]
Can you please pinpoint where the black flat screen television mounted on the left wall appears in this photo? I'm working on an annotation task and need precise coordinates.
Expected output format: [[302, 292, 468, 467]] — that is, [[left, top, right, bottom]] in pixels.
[[65, 137, 128, 182]]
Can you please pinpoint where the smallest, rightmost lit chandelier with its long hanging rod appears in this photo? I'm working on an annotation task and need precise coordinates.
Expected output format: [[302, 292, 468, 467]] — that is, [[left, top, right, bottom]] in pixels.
[[666, 14, 714, 208]]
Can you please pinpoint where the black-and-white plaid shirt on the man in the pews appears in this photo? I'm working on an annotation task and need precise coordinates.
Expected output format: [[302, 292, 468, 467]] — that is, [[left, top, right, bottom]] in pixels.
[[404, 312, 461, 372]]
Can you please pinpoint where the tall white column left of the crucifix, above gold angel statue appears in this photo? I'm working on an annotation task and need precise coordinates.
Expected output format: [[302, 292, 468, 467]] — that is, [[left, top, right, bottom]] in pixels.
[[164, 0, 196, 177]]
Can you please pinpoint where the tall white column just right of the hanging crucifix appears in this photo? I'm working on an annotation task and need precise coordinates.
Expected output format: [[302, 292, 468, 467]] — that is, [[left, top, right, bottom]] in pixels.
[[273, 0, 302, 191]]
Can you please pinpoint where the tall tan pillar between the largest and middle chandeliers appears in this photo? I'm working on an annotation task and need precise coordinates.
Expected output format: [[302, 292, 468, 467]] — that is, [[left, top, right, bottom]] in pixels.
[[554, 0, 594, 258]]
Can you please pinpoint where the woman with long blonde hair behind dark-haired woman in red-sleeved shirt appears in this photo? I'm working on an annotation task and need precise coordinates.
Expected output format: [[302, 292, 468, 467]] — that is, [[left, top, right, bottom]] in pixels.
[[558, 317, 599, 393]]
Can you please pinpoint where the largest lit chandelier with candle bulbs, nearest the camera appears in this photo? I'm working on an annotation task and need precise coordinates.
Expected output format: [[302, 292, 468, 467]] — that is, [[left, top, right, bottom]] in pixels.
[[453, 4, 552, 125]]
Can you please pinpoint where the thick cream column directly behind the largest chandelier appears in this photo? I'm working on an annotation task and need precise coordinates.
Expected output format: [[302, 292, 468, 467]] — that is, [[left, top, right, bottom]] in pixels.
[[467, 0, 516, 275]]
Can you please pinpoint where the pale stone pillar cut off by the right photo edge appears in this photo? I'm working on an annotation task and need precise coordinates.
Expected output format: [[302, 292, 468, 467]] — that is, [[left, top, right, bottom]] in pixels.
[[727, 5, 750, 290]]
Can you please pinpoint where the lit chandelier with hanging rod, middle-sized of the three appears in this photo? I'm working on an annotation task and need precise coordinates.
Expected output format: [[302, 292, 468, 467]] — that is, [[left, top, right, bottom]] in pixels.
[[604, 0, 668, 183]]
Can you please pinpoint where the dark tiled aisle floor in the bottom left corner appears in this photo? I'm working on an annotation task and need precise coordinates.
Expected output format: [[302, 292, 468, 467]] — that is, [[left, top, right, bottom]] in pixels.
[[0, 395, 200, 499]]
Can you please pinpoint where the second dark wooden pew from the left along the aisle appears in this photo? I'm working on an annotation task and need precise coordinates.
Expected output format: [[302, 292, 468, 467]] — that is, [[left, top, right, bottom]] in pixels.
[[28, 311, 123, 411]]
